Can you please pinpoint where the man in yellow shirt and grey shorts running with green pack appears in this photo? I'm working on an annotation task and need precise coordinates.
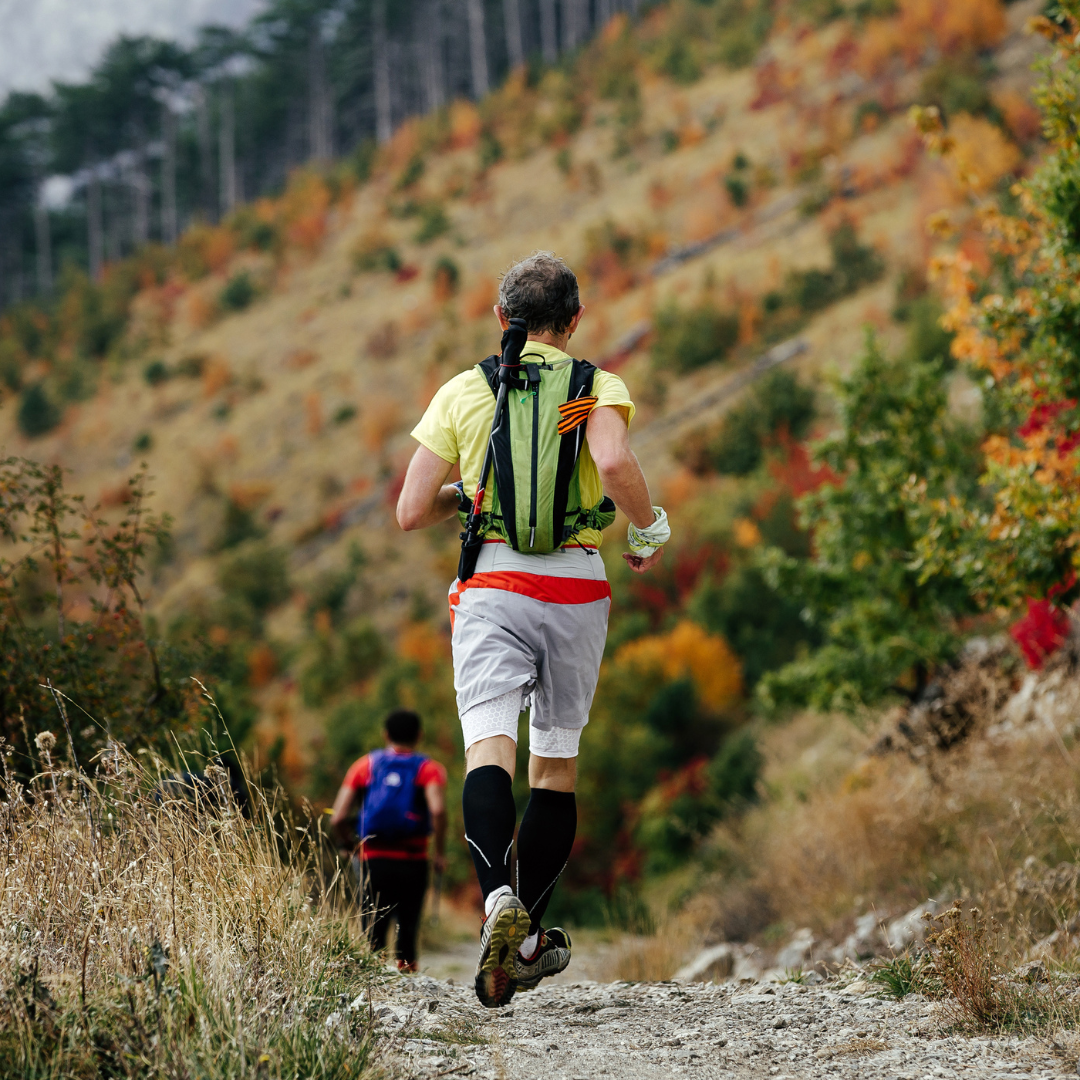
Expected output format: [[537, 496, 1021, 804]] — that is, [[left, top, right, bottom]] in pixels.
[[397, 252, 670, 1008]]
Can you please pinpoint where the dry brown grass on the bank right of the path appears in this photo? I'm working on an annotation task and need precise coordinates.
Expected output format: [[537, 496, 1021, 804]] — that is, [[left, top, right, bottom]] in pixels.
[[697, 699, 1080, 951]]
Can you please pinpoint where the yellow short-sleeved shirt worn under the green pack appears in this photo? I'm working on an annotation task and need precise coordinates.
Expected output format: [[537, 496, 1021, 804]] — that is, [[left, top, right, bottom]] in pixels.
[[413, 341, 634, 548]]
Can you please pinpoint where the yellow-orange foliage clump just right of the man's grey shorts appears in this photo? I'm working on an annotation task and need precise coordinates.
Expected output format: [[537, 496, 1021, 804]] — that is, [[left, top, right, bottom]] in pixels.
[[615, 621, 742, 712]]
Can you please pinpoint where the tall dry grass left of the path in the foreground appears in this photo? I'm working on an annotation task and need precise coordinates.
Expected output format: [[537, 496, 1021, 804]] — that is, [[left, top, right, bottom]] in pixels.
[[0, 704, 377, 1080]]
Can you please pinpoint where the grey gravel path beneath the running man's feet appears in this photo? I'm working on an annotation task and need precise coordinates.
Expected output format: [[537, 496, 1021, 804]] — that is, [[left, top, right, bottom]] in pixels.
[[353, 975, 1077, 1080]]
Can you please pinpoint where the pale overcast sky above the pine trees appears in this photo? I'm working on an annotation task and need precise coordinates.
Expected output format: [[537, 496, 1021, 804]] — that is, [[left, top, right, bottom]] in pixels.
[[0, 0, 261, 94]]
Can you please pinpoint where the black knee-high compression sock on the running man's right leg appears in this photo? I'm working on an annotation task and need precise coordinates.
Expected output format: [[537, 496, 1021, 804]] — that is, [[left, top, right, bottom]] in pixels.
[[517, 787, 578, 934]]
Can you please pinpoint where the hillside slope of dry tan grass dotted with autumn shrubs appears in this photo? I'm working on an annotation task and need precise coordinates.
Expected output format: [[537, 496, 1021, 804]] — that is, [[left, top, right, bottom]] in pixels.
[[0, 0, 1039, 842]]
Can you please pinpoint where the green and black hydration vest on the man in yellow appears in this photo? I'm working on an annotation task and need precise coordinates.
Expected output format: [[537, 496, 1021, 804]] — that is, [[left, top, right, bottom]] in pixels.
[[459, 351, 616, 555]]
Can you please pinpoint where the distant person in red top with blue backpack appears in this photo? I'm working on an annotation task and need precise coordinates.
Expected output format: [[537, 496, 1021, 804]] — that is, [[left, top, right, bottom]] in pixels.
[[330, 708, 446, 972]]
